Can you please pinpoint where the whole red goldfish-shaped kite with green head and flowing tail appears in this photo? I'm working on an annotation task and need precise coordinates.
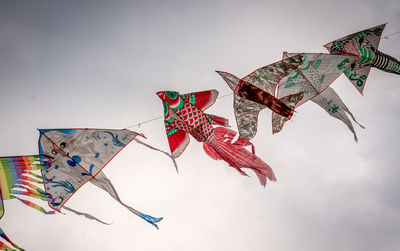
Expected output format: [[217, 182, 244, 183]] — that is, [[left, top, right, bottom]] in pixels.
[[157, 90, 276, 186]]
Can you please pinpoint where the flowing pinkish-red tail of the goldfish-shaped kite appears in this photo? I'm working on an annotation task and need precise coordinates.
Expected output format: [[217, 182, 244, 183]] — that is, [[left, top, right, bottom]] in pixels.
[[203, 127, 276, 186]]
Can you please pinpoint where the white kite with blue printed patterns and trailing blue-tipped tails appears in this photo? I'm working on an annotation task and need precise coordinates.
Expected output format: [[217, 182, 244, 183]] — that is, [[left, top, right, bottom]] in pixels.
[[39, 129, 162, 229]]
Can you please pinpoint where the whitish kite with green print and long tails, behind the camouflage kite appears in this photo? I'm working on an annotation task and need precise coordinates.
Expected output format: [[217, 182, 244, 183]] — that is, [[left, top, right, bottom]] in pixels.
[[272, 52, 362, 141]]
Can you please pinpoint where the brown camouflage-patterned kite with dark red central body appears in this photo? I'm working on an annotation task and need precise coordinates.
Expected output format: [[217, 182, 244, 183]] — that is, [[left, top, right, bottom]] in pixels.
[[217, 55, 303, 140]]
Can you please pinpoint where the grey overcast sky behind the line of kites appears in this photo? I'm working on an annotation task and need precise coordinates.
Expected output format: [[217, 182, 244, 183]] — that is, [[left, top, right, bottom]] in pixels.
[[0, 0, 400, 251]]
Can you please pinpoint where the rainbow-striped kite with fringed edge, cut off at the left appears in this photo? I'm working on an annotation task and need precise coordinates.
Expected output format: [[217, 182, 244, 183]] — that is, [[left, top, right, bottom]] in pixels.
[[0, 155, 54, 250]]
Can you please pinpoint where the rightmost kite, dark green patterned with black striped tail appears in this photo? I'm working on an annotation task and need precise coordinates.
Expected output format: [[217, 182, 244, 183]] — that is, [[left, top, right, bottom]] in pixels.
[[324, 24, 400, 94]]
